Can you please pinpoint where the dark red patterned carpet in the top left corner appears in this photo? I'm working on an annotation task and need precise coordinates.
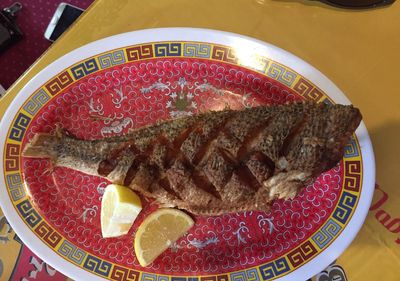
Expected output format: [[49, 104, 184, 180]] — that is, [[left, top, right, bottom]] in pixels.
[[0, 0, 93, 89]]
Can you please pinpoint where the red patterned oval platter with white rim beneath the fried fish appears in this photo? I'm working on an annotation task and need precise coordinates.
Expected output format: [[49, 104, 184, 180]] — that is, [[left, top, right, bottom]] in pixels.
[[0, 28, 375, 281]]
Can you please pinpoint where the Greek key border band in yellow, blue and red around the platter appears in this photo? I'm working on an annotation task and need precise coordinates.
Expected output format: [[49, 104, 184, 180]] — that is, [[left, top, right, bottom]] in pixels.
[[3, 42, 363, 281]]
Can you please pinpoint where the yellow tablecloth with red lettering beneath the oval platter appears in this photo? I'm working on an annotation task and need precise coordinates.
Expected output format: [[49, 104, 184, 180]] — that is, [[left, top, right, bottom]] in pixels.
[[0, 0, 400, 281]]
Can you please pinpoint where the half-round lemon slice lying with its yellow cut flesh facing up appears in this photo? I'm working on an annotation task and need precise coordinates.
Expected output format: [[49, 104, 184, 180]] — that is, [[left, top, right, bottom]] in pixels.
[[135, 208, 194, 266]]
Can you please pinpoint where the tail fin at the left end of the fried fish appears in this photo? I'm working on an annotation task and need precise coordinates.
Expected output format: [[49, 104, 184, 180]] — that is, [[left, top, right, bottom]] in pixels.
[[22, 134, 61, 158]]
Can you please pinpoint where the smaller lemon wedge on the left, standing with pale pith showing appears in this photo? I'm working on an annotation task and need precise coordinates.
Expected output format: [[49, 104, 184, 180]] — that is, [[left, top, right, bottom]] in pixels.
[[100, 184, 142, 238]]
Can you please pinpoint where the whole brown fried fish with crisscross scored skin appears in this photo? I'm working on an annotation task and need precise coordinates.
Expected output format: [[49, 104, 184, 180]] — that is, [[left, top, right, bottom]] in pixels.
[[23, 102, 362, 215]]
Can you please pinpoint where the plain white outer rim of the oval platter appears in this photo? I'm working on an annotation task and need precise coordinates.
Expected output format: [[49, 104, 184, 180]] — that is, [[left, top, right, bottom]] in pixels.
[[0, 27, 375, 281]]
